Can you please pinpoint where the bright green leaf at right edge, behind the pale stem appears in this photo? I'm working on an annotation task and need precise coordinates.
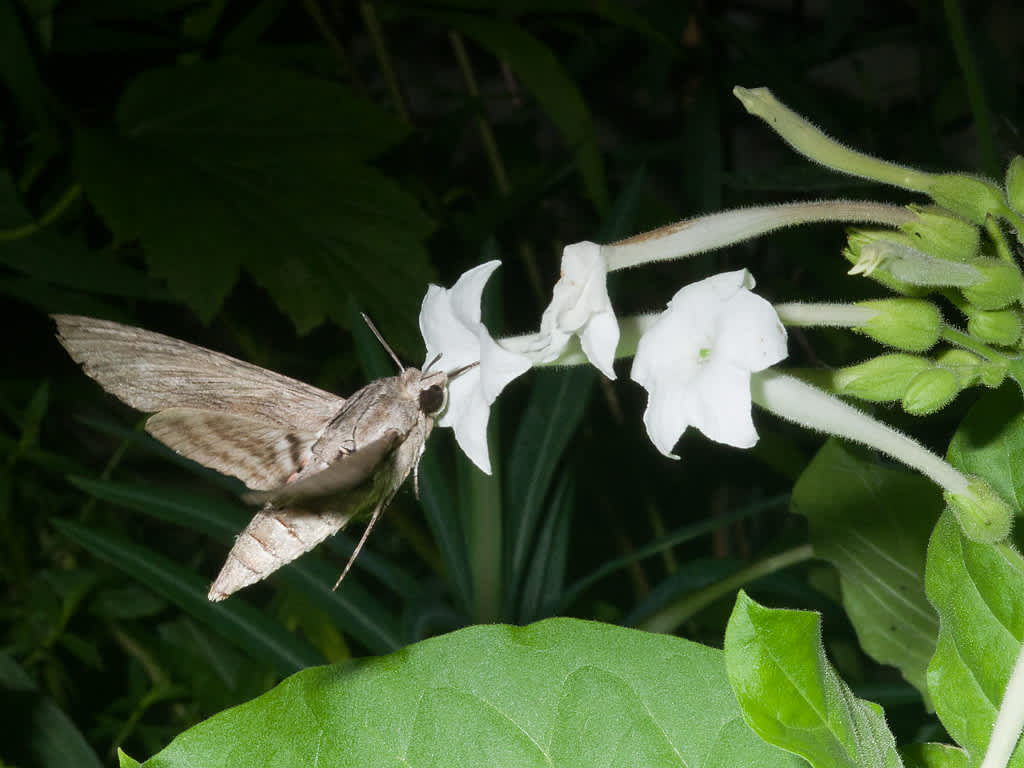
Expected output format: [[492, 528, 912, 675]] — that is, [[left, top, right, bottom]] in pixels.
[[926, 512, 1024, 766]]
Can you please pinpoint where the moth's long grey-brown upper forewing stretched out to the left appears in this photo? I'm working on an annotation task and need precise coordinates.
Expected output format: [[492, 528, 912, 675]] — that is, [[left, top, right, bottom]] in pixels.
[[52, 314, 345, 433]]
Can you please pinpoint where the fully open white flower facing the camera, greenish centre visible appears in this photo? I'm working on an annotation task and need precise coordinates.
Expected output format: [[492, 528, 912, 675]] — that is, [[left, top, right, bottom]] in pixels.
[[631, 269, 786, 459]]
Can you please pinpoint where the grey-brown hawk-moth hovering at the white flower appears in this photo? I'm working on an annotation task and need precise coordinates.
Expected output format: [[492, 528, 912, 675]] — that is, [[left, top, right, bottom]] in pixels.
[[53, 314, 475, 601]]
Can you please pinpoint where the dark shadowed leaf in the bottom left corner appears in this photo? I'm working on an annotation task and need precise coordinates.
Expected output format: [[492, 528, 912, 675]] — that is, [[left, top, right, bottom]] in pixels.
[[0, 651, 102, 768]]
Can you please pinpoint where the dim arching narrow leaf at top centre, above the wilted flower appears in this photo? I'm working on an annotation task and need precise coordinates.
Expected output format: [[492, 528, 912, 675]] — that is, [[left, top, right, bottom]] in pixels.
[[440, 12, 608, 213]]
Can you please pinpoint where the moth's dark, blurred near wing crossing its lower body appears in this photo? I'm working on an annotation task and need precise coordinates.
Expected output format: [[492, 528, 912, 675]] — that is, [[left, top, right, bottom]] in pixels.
[[242, 429, 404, 508]]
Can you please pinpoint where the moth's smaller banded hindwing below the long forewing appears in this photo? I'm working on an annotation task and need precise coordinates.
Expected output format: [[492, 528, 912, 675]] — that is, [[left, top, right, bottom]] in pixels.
[[145, 408, 316, 490]]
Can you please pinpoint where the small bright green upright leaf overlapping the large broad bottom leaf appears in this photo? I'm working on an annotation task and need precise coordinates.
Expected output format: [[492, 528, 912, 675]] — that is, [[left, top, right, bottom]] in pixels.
[[725, 592, 902, 768]]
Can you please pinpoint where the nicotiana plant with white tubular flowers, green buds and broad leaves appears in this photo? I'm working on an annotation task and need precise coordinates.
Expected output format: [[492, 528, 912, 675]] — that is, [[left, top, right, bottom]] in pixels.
[[122, 88, 1024, 768]]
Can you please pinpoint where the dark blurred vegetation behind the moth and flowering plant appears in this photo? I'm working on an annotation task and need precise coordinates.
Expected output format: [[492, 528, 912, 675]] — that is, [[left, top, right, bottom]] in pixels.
[[0, 0, 1024, 766]]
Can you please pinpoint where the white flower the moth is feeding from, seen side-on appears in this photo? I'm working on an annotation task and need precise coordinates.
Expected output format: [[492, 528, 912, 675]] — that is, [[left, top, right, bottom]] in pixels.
[[420, 261, 530, 474]]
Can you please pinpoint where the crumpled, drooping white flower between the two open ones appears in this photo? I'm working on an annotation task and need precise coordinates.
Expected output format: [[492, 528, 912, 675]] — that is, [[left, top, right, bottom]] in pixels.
[[536, 242, 618, 379]]
